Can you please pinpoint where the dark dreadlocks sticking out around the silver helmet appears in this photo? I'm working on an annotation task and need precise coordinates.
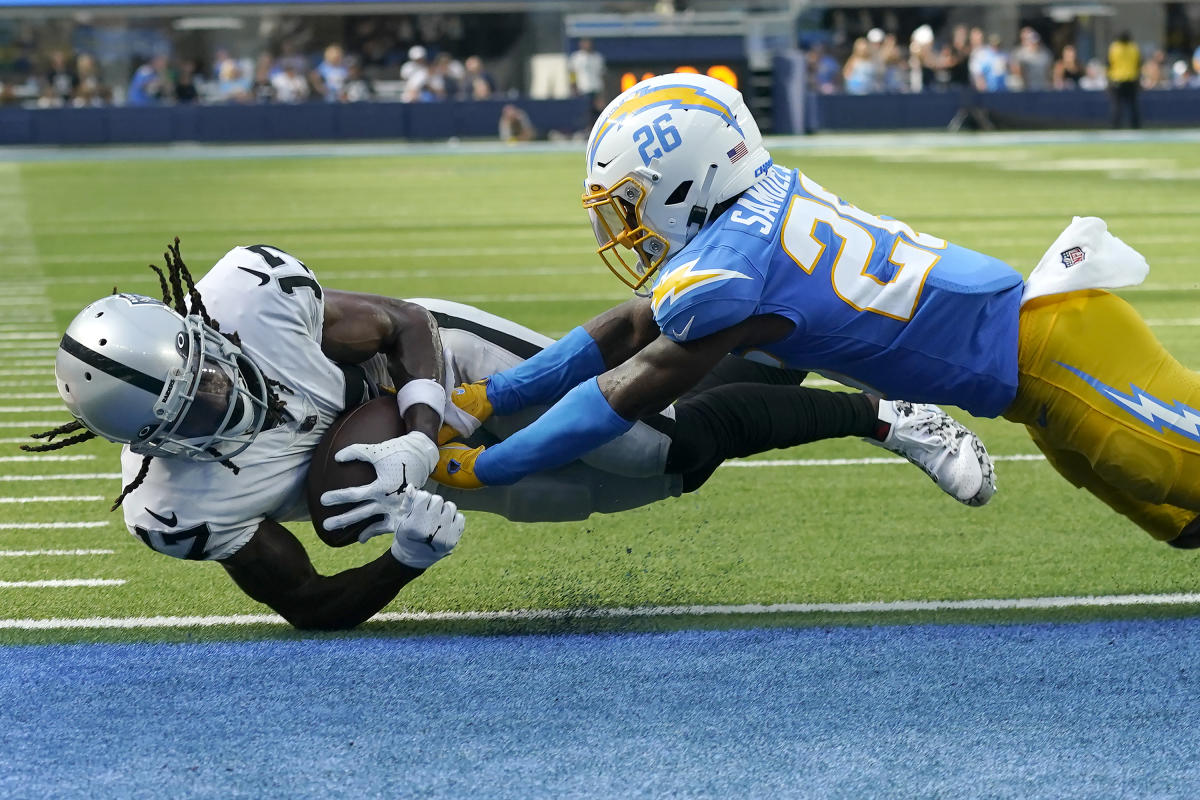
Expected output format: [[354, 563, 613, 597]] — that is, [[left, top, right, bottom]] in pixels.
[[20, 236, 294, 511]]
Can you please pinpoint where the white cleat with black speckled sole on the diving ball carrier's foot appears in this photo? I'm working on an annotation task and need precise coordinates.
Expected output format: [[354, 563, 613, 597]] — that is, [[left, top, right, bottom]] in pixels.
[[865, 399, 996, 506]]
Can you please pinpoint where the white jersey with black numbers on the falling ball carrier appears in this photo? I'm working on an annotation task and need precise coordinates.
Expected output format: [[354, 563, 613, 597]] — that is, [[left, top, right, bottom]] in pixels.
[[121, 245, 376, 559]]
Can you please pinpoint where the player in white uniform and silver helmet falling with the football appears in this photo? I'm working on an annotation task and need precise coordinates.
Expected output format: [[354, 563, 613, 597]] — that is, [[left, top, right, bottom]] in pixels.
[[35, 240, 990, 628]]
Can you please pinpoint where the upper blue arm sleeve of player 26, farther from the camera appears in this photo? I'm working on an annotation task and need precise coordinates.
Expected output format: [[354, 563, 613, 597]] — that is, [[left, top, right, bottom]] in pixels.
[[487, 326, 605, 414]]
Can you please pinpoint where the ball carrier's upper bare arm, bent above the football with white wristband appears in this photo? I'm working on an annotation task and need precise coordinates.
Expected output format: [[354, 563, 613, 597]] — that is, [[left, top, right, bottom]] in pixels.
[[320, 289, 444, 439]]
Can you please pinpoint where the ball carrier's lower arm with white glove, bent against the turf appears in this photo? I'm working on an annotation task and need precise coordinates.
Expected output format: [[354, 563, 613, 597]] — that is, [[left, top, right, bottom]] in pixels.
[[221, 489, 464, 630]]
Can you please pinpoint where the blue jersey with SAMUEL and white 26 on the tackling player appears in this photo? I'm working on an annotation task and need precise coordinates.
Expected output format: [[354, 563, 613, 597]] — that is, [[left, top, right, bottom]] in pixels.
[[652, 166, 1024, 416]]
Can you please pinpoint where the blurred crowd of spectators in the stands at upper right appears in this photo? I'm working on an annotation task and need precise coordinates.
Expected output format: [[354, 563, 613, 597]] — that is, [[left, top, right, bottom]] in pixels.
[[808, 25, 1200, 95]]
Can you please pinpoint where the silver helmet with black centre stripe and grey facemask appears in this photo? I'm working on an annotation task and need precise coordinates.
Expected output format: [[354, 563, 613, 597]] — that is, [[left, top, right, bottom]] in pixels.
[[54, 294, 268, 461]]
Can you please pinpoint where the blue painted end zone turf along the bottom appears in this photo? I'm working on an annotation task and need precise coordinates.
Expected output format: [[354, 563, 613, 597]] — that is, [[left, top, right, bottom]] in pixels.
[[0, 619, 1200, 799]]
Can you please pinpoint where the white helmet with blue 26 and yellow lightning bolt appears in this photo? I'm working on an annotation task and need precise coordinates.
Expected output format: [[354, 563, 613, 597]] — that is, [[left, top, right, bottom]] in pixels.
[[583, 73, 770, 294]]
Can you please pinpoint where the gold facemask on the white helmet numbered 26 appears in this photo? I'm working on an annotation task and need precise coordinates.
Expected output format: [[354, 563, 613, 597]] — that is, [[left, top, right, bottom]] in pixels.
[[583, 178, 670, 291]]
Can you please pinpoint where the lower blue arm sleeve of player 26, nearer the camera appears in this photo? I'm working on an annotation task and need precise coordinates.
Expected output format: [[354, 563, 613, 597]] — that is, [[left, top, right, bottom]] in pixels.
[[475, 378, 634, 486]]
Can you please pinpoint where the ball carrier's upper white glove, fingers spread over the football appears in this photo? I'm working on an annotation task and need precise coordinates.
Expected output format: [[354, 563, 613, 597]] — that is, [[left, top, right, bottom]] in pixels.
[[320, 432, 438, 541]]
